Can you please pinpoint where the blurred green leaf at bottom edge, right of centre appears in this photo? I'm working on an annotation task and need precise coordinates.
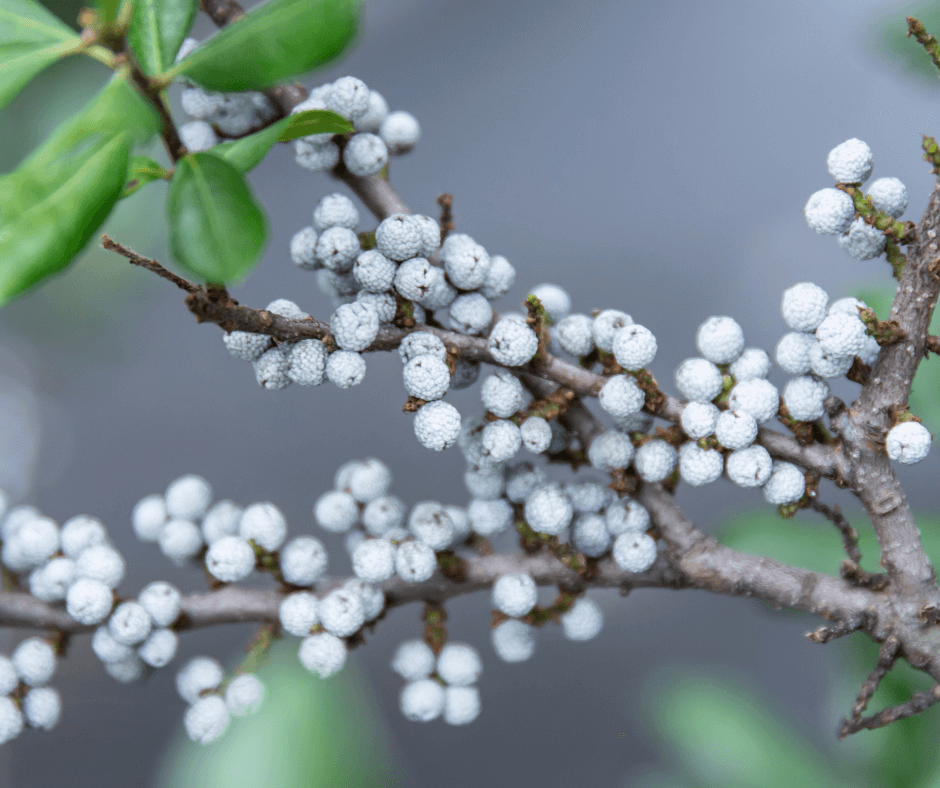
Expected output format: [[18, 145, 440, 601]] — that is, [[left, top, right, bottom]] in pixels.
[[649, 673, 844, 788]]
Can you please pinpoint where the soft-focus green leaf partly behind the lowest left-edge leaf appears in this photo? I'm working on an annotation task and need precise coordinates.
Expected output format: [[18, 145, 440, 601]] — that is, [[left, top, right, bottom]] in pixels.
[[0, 74, 160, 224]]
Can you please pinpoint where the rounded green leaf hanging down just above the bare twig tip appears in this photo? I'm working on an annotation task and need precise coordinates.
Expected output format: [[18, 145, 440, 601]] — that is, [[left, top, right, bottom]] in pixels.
[[166, 153, 267, 284]]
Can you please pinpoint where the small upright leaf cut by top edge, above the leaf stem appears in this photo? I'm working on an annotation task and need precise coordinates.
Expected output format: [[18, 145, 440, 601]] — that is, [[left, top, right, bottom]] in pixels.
[[127, 0, 199, 74]]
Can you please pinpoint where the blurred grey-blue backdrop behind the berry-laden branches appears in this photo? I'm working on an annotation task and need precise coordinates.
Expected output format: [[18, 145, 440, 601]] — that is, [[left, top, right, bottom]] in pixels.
[[0, 0, 940, 788]]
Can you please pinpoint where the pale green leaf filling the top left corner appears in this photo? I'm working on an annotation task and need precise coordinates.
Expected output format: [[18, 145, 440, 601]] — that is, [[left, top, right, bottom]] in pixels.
[[0, 0, 81, 109]]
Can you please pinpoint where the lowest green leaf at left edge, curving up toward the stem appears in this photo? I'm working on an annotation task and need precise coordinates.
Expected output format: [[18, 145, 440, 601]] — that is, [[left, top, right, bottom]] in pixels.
[[0, 134, 130, 303]]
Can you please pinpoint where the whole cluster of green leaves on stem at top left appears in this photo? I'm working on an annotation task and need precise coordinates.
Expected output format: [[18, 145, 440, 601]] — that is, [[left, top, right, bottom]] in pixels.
[[0, 0, 359, 305]]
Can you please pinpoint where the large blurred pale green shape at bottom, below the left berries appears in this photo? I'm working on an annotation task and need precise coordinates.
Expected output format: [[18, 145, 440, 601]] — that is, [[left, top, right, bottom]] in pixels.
[[154, 639, 400, 788]]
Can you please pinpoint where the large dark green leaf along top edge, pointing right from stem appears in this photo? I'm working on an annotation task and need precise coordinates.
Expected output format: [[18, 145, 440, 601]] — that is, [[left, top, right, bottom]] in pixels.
[[172, 0, 359, 91]]
